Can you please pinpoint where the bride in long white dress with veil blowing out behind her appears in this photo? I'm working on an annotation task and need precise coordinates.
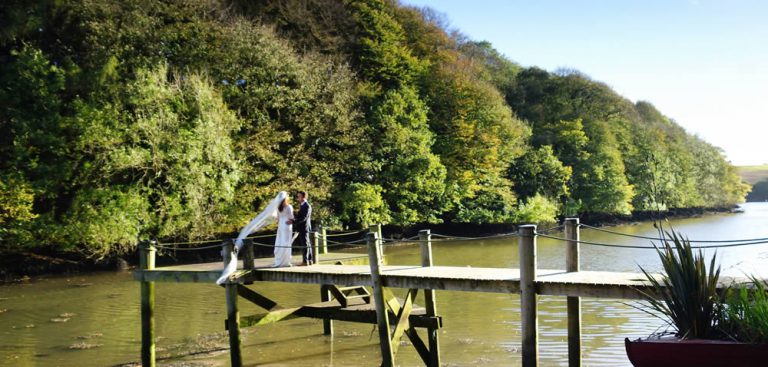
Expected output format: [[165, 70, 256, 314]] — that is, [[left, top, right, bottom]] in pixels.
[[216, 191, 293, 284]]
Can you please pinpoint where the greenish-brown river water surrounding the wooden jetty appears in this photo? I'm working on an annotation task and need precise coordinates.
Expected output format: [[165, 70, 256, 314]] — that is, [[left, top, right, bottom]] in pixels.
[[0, 203, 768, 367]]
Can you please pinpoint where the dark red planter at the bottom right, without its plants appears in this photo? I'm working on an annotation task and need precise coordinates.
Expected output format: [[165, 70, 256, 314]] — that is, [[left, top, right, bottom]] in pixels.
[[624, 337, 768, 367]]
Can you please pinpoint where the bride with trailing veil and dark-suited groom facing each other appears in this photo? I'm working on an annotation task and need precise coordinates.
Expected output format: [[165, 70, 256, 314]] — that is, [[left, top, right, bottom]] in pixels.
[[216, 191, 315, 284]]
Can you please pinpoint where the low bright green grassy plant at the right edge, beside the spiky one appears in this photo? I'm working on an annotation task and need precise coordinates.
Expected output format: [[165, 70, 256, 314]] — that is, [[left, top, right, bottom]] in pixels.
[[720, 276, 768, 343]]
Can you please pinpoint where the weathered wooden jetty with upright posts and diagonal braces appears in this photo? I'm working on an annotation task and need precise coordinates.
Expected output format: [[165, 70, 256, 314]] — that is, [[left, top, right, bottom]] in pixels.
[[134, 218, 748, 366]]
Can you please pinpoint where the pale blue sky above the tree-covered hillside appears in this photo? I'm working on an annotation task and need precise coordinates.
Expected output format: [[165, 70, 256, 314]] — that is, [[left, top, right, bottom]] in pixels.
[[402, 0, 768, 165]]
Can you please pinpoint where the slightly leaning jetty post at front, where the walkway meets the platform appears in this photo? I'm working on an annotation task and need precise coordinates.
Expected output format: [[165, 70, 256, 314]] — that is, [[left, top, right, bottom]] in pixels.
[[368, 233, 395, 367]]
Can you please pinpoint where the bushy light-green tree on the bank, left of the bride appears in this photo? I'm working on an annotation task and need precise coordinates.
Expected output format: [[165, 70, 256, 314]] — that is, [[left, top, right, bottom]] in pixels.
[[66, 65, 242, 255]]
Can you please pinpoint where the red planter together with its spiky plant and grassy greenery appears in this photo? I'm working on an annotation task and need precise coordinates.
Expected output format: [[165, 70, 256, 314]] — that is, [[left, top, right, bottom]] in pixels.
[[624, 231, 768, 367]]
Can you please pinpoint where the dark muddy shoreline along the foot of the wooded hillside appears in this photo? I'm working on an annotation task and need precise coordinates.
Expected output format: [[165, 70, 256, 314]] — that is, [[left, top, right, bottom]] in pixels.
[[0, 207, 737, 284]]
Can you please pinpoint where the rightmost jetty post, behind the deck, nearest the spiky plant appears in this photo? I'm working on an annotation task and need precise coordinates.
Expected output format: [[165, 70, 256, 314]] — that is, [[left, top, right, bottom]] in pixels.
[[565, 218, 581, 367]]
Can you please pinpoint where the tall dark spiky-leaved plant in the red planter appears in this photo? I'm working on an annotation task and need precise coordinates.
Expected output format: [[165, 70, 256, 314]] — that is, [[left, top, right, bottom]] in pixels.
[[641, 230, 720, 339]]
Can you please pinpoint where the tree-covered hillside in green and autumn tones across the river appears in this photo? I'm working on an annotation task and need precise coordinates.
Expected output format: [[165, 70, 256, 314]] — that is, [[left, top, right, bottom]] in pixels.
[[0, 0, 748, 257]]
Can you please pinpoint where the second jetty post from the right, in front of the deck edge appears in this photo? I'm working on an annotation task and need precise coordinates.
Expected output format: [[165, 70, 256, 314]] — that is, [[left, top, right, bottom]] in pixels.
[[518, 224, 539, 367]]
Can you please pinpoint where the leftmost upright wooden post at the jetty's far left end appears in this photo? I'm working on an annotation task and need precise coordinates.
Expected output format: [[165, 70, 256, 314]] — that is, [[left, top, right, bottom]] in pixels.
[[139, 241, 157, 367]]
